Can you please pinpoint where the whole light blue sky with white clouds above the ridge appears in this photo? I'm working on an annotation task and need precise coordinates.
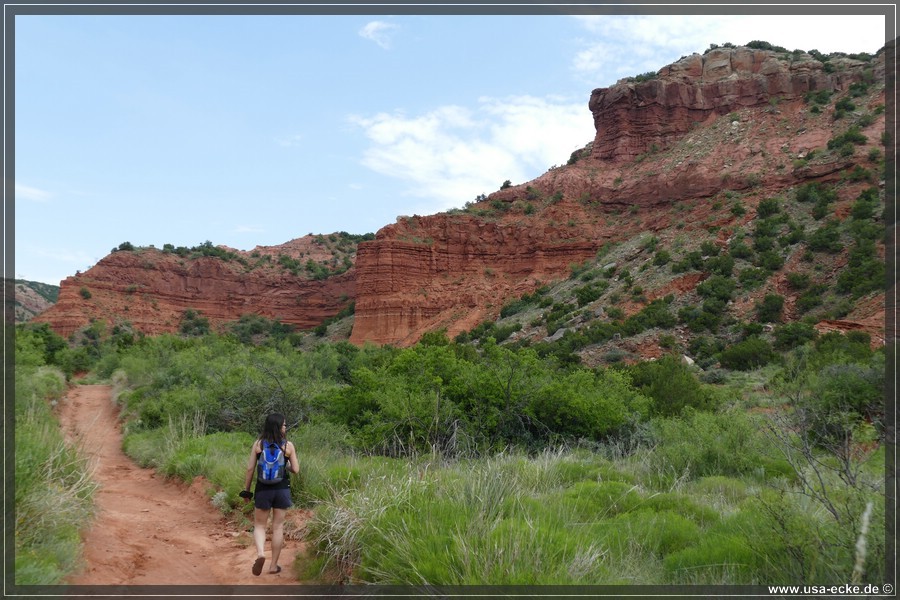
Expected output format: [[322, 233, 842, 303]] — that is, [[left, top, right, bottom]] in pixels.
[[15, 7, 885, 285]]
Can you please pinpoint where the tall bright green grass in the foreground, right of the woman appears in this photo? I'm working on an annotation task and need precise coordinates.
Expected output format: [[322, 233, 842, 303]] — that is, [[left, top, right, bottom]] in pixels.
[[306, 442, 883, 585]]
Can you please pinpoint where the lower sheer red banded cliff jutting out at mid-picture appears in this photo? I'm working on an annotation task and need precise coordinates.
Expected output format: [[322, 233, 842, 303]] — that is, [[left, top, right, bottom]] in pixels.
[[350, 215, 602, 345]]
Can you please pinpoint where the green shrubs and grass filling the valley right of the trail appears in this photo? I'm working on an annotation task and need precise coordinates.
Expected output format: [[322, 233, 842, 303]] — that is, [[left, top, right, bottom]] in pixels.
[[17, 310, 885, 585]]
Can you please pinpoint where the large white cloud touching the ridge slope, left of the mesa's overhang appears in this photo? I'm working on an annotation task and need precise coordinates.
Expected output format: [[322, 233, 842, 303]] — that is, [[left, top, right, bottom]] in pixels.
[[350, 96, 593, 214]]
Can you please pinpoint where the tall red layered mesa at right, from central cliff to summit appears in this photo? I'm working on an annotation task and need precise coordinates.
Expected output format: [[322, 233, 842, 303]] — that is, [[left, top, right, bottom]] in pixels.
[[351, 48, 884, 345]]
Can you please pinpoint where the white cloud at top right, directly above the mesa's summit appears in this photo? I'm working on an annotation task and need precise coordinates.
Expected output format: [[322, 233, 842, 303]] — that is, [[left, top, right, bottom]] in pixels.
[[572, 14, 884, 86]]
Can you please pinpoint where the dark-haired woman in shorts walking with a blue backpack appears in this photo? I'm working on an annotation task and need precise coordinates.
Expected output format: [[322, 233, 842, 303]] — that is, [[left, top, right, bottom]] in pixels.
[[240, 413, 300, 575]]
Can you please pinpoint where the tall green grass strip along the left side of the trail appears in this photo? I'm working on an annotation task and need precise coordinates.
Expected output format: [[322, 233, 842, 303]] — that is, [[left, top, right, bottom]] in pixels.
[[15, 366, 96, 585]]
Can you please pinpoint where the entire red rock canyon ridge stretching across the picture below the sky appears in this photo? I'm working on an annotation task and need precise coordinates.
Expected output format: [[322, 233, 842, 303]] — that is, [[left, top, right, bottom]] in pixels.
[[33, 43, 893, 356]]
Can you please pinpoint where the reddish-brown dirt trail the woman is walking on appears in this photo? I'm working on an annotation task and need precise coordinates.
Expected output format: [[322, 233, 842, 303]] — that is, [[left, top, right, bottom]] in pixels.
[[59, 385, 307, 585]]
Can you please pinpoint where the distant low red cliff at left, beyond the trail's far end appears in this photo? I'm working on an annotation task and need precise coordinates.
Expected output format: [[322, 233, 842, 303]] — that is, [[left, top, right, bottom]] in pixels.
[[34, 244, 356, 336]]
